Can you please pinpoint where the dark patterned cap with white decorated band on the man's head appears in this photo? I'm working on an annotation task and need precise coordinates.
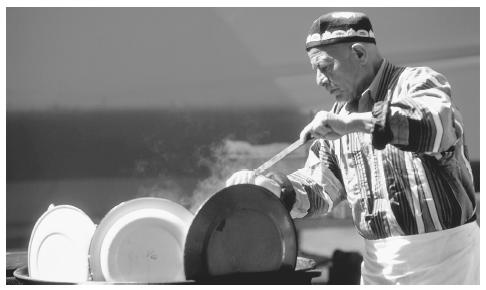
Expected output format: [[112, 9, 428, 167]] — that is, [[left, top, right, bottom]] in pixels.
[[305, 12, 376, 50]]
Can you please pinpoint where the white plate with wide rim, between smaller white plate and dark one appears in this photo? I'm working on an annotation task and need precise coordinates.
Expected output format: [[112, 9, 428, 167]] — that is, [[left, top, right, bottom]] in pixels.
[[89, 197, 193, 283]]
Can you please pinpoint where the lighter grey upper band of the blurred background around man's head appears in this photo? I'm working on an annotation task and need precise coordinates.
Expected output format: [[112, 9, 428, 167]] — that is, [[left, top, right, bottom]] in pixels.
[[6, 7, 480, 159]]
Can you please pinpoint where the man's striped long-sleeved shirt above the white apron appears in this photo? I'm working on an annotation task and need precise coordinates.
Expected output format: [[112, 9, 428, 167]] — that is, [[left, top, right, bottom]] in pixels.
[[288, 60, 476, 240]]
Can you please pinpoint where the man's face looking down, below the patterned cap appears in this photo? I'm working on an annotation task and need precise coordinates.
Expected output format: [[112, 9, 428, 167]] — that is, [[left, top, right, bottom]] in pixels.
[[307, 43, 359, 102]]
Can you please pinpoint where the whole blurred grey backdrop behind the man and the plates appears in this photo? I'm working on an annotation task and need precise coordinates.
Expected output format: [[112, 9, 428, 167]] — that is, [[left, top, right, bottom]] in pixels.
[[6, 7, 480, 284]]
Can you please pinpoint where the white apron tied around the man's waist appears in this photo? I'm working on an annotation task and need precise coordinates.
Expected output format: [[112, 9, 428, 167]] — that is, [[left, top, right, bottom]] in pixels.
[[361, 222, 480, 285]]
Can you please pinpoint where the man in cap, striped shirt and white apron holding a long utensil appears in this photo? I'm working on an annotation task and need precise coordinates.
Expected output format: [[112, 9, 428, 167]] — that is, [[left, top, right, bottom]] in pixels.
[[227, 12, 479, 284]]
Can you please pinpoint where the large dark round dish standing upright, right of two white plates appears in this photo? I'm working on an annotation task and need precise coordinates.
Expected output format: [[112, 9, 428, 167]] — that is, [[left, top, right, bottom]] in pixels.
[[184, 184, 297, 280]]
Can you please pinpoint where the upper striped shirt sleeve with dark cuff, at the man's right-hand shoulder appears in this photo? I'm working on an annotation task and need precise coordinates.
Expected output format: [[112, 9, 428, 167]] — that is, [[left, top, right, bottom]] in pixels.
[[372, 67, 462, 154]]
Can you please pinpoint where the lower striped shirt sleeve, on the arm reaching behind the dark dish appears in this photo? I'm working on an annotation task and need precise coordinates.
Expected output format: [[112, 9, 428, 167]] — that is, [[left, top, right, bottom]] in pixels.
[[288, 139, 346, 218]]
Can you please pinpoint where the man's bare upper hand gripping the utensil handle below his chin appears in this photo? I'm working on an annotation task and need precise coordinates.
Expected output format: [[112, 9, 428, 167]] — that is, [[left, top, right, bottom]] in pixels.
[[300, 111, 350, 140]]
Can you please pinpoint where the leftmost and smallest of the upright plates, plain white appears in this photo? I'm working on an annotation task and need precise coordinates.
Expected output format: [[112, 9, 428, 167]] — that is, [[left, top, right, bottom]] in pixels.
[[27, 205, 96, 282]]
